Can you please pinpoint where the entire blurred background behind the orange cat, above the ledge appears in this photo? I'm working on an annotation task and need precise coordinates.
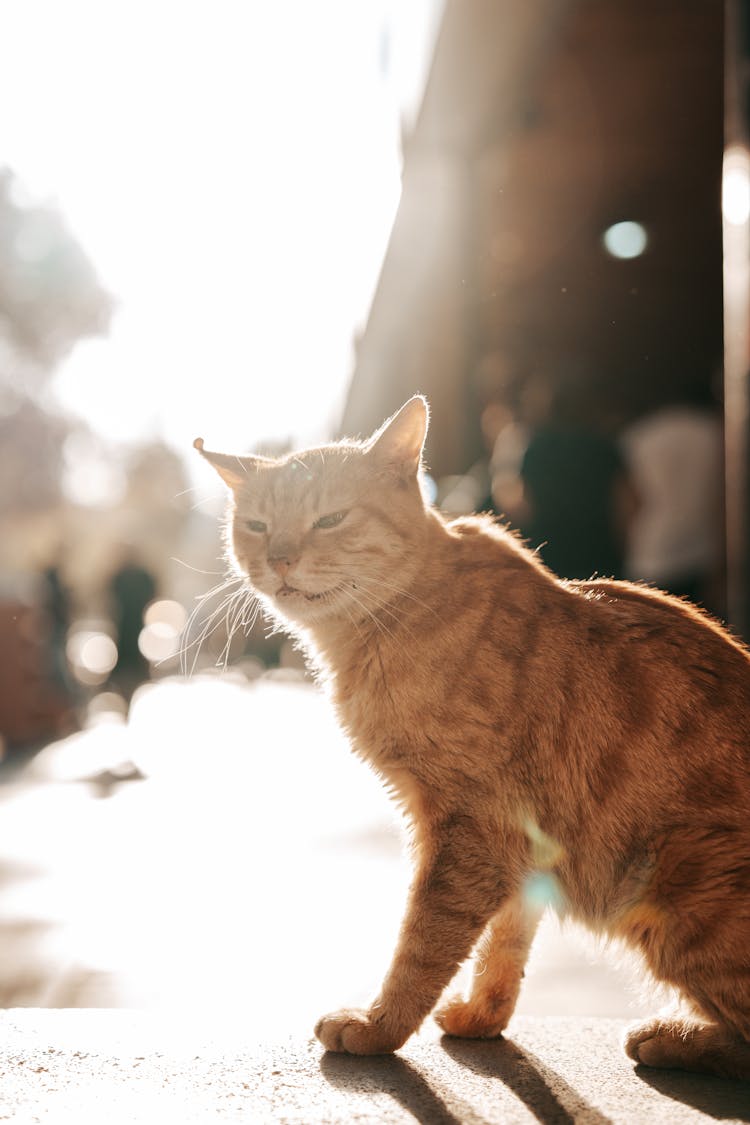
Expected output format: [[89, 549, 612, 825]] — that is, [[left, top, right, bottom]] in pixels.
[[0, 0, 750, 1027]]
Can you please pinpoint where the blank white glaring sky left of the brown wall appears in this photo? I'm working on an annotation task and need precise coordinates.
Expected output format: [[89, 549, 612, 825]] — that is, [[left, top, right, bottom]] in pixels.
[[0, 0, 442, 463]]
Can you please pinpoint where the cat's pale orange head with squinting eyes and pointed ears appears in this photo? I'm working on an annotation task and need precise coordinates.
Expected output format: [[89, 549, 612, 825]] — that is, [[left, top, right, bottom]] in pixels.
[[195, 396, 428, 627]]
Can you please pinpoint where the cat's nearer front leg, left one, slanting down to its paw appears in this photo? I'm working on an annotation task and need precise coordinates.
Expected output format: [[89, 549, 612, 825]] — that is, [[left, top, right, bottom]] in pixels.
[[315, 838, 509, 1054]]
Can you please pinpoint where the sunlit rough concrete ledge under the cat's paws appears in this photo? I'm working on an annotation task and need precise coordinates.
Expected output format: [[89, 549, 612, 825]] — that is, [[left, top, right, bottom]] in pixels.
[[0, 1009, 750, 1125]]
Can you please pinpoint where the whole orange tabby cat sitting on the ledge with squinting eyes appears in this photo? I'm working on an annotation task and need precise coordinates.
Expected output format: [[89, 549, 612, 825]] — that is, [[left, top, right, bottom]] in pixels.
[[196, 397, 750, 1078]]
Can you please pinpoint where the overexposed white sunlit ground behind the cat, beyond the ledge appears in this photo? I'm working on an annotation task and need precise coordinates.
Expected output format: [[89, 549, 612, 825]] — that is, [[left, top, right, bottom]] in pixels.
[[0, 674, 652, 1038]]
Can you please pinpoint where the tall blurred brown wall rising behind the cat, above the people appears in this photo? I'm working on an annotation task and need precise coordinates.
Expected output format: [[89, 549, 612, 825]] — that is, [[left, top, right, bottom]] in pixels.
[[342, 0, 723, 475]]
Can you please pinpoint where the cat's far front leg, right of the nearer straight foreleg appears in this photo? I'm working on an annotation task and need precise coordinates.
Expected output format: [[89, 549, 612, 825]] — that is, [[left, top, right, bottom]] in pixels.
[[435, 893, 541, 1040]]
